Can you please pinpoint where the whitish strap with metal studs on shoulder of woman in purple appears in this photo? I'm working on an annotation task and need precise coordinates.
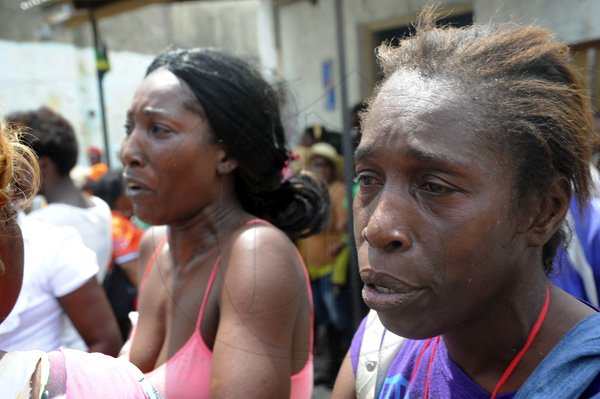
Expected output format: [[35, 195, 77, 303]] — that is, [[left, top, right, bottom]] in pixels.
[[356, 310, 405, 399]]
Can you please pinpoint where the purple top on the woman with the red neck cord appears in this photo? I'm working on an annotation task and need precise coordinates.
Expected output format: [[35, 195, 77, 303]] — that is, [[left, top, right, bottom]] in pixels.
[[350, 318, 600, 399]]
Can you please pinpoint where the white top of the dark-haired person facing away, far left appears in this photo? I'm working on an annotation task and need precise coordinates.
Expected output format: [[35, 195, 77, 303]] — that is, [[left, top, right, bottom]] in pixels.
[[28, 196, 112, 283]]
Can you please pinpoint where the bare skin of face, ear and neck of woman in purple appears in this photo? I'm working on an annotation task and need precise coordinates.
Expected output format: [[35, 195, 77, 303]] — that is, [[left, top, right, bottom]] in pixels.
[[333, 72, 594, 398]]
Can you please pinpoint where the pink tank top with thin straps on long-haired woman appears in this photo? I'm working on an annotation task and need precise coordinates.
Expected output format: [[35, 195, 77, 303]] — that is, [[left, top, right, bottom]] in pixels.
[[137, 219, 314, 399]]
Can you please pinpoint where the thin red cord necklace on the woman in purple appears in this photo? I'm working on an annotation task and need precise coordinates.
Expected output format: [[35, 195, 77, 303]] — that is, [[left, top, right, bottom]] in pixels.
[[406, 287, 550, 399]]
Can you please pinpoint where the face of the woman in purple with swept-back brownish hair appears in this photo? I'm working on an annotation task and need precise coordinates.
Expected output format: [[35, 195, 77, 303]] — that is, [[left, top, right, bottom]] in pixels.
[[354, 72, 541, 338]]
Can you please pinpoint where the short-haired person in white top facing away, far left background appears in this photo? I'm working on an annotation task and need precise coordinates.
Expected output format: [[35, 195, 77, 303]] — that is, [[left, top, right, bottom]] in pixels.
[[6, 107, 118, 350]]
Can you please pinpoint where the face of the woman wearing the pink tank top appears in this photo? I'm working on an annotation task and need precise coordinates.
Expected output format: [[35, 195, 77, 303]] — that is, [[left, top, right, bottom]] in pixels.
[[121, 69, 225, 225]]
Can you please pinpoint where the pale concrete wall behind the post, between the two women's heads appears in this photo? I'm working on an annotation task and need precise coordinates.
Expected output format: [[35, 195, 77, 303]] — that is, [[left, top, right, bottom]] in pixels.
[[279, 0, 471, 136]]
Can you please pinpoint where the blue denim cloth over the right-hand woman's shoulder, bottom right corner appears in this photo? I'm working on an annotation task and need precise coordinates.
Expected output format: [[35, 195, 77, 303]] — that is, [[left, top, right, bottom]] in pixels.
[[515, 313, 600, 399]]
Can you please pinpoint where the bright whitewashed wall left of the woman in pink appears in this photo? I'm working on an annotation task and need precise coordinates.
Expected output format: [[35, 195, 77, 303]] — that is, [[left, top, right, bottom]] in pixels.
[[0, 40, 152, 165]]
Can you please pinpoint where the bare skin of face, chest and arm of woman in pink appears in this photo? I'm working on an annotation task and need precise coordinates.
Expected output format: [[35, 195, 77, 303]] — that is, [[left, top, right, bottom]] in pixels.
[[121, 69, 310, 398]]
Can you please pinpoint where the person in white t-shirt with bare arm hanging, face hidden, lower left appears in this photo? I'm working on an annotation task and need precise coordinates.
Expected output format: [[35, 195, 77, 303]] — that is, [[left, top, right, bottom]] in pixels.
[[0, 213, 121, 355]]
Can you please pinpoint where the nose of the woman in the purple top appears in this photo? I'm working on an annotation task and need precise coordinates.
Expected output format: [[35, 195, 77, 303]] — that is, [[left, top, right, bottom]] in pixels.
[[361, 192, 413, 251]]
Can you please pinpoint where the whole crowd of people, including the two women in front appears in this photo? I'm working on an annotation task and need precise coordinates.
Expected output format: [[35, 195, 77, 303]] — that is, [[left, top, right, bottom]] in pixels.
[[0, 9, 600, 399]]
